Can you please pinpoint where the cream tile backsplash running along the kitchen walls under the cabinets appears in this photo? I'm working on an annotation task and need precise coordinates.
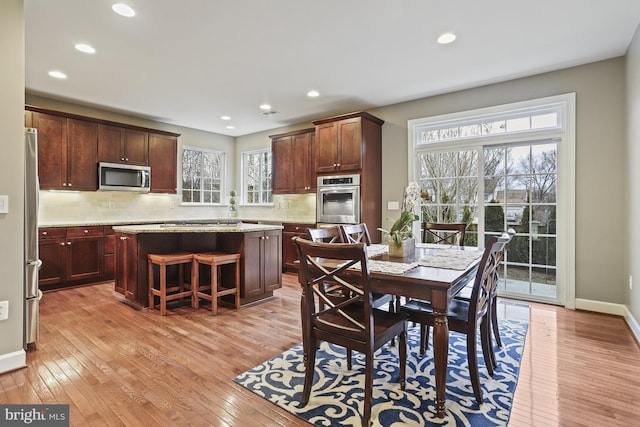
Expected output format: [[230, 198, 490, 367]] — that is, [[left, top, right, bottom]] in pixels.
[[39, 191, 316, 225]]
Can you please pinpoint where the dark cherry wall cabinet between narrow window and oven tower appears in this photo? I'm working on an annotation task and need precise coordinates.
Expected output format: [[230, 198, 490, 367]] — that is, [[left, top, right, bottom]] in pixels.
[[270, 128, 316, 194]]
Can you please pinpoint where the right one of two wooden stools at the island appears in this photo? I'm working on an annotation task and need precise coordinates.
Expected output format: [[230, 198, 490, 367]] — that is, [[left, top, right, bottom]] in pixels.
[[191, 253, 240, 315]]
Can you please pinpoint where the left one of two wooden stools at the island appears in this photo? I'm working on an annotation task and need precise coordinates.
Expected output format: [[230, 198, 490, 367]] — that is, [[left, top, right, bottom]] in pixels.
[[147, 253, 193, 316]]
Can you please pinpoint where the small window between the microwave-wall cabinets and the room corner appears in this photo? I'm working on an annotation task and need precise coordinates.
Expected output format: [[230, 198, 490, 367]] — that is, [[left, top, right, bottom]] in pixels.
[[182, 147, 226, 204]]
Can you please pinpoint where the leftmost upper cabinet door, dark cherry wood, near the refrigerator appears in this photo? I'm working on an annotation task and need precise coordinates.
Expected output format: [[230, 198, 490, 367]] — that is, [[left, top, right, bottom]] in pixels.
[[33, 113, 67, 190]]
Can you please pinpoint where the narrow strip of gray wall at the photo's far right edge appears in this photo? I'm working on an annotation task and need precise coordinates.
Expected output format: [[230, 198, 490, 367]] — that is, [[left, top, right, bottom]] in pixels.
[[621, 27, 640, 321]]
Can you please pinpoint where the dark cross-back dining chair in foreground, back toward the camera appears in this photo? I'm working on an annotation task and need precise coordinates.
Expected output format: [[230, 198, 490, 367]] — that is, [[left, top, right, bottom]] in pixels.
[[293, 237, 407, 426]]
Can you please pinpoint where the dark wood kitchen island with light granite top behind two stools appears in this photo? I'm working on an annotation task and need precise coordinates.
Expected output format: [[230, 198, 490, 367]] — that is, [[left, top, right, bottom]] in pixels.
[[113, 221, 282, 308]]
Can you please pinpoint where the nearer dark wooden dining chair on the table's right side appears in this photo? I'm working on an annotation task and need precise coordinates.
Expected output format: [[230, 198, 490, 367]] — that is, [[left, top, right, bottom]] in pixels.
[[400, 237, 506, 405]]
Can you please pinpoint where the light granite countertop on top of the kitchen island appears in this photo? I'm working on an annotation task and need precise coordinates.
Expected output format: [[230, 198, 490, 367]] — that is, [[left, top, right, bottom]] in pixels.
[[113, 222, 282, 234]]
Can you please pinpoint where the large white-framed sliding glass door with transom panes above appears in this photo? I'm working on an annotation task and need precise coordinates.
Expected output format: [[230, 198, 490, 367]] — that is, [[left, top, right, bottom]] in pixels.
[[409, 94, 575, 308]]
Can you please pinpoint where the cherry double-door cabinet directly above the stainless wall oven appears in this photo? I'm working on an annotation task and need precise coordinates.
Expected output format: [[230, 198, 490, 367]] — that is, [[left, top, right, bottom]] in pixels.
[[313, 112, 384, 174]]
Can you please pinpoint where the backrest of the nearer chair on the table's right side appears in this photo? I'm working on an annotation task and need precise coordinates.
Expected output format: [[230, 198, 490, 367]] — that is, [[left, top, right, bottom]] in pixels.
[[468, 237, 508, 325]]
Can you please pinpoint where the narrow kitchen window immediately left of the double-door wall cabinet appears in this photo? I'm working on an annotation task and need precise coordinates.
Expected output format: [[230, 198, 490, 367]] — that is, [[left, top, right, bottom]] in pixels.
[[242, 149, 273, 205]]
